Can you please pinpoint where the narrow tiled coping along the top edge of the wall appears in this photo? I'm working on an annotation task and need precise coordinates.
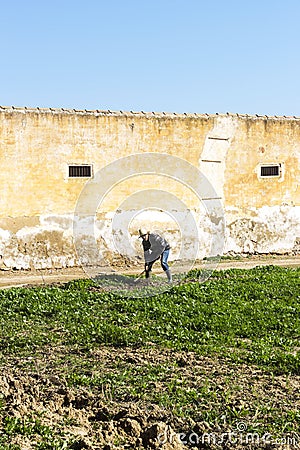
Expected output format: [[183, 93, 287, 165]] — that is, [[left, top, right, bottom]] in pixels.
[[0, 105, 300, 120]]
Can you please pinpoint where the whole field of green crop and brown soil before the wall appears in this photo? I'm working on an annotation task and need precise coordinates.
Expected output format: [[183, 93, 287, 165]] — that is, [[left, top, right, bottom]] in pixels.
[[0, 266, 300, 450]]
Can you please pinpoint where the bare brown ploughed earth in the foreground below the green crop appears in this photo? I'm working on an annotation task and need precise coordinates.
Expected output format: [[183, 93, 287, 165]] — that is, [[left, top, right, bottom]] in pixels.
[[0, 347, 300, 450]]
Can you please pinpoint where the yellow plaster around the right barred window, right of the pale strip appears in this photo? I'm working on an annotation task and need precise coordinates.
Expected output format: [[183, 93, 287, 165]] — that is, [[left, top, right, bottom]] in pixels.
[[225, 117, 300, 208]]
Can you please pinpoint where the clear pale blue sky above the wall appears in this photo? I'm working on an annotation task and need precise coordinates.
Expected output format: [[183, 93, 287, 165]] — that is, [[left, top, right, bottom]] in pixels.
[[0, 0, 300, 116]]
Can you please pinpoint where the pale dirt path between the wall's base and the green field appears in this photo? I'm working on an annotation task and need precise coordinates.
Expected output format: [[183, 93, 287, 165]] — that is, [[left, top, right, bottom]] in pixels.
[[0, 255, 300, 289]]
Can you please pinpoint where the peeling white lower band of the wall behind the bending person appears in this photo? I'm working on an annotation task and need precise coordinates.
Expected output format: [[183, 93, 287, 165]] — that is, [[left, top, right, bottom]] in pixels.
[[0, 206, 300, 269]]
